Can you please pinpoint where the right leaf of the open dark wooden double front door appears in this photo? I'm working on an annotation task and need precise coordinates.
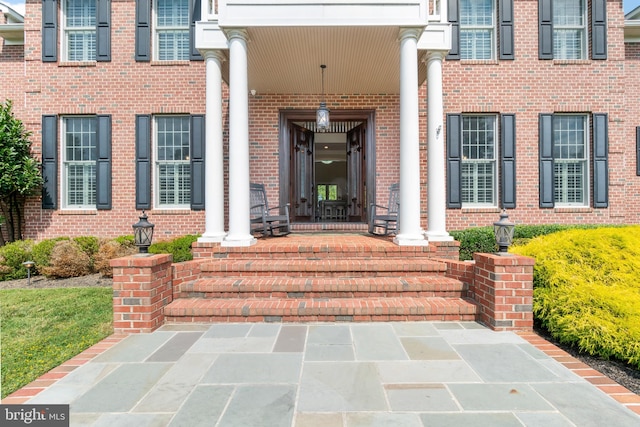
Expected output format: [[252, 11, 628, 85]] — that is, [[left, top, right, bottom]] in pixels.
[[347, 123, 367, 221]]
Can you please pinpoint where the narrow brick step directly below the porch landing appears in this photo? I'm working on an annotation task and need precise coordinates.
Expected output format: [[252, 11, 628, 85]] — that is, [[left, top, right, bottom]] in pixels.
[[200, 258, 446, 277]]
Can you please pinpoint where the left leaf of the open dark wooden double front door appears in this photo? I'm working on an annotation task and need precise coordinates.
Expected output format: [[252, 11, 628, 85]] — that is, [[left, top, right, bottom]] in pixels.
[[289, 123, 315, 222]]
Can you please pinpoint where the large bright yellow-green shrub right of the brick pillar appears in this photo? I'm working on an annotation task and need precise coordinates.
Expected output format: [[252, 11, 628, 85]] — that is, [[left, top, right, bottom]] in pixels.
[[512, 226, 640, 367]]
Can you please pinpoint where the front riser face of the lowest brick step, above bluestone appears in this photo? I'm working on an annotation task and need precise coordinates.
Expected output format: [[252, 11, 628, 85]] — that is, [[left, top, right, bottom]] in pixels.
[[165, 314, 477, 323]]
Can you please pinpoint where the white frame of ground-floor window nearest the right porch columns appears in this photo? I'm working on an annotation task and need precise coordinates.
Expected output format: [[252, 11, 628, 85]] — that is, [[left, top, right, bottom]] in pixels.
[[461, 114, 500, 208]]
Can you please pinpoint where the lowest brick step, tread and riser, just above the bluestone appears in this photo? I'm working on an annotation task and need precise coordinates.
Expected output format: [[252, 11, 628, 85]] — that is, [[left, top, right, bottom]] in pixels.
[[164, 297, 477, 323]]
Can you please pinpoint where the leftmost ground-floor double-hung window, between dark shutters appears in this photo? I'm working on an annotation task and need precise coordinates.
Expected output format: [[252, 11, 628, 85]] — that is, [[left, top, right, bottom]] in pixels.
[[61, 116, 97, 209]]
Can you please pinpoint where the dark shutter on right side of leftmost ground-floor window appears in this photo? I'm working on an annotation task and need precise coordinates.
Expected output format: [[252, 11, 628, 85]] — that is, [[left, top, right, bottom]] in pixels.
[[96, 115, 111, 209]]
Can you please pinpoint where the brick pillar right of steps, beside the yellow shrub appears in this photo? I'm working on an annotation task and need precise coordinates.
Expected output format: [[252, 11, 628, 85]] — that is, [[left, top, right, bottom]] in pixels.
[[473, 253, 535, 331]]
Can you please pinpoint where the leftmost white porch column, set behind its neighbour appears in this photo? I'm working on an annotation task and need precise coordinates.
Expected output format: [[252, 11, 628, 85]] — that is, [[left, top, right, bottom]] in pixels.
[[198, 50, 227, 242]]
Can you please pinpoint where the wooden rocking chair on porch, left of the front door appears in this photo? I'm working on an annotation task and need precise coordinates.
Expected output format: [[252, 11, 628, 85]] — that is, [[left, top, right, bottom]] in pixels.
[[249, 183, 291, 236]]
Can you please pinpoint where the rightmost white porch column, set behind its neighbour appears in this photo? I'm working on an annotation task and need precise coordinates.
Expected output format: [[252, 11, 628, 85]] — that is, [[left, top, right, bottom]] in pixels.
[[426, 52, 453, 241]]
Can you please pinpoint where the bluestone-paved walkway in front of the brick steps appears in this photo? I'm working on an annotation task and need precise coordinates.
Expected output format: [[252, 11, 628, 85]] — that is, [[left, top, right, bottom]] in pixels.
[[11, 322, 640, 427]]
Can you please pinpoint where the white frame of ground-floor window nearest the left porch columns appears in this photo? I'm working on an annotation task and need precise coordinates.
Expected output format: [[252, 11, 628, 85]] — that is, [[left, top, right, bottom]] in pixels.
[[153, 114, 191, 209]]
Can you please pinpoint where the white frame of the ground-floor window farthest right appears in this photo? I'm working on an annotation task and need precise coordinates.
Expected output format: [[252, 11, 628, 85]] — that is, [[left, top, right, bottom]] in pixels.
[[553, 114, 591, 207]]
